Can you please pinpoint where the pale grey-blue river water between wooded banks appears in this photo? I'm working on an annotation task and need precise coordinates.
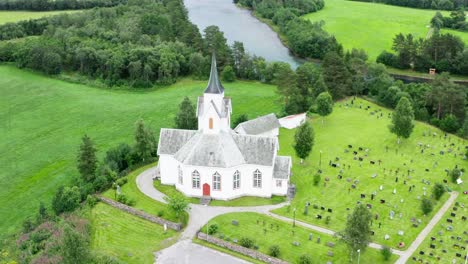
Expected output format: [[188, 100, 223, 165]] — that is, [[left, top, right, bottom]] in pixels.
[[184, 0, 302, 69]]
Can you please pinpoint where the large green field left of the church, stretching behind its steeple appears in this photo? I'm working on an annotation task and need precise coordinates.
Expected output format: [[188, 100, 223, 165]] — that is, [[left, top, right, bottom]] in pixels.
[[0, 65, 280, 239]]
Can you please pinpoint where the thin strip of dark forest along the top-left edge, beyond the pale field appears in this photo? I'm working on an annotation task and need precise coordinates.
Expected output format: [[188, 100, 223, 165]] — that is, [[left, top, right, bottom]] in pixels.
[[0, 0, 127, 11]]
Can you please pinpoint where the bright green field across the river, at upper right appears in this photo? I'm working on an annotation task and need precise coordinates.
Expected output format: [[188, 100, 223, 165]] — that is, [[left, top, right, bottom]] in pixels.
[[304, 0, 468, 61]]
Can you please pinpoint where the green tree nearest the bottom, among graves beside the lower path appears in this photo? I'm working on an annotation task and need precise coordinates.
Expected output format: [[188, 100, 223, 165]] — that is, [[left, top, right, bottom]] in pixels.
[[342, 204, 372, 254]]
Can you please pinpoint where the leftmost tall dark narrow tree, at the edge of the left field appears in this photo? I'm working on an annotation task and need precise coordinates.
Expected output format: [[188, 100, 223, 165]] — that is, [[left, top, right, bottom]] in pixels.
[[78, 135, 97, 182]]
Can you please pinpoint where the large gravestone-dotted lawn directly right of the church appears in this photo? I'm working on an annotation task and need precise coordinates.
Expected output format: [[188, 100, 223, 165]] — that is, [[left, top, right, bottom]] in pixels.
[[274, 99, 468, 249]]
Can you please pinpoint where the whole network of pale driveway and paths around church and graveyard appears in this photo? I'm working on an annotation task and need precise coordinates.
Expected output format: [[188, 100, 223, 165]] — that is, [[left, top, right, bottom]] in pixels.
[[136, 168, 458, 264]]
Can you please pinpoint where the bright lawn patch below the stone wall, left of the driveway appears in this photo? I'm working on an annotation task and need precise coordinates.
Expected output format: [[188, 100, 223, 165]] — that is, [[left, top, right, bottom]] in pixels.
[[89, 203, 178, 264]]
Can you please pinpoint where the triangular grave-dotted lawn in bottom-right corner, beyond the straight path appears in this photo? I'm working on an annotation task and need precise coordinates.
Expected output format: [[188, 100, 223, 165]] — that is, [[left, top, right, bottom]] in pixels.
[[412, 196, 468, 263]]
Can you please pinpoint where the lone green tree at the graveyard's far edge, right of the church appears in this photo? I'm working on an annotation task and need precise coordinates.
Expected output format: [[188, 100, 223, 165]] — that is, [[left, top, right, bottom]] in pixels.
[[390, 97, 414, 144]]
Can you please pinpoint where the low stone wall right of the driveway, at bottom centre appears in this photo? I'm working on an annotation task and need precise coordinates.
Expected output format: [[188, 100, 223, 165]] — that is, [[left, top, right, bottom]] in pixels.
[[197, 232, 288, 264]]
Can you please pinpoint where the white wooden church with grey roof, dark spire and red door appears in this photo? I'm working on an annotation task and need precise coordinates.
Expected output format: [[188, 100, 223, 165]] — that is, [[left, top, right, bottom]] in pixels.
[[158, 56, 292, 200]]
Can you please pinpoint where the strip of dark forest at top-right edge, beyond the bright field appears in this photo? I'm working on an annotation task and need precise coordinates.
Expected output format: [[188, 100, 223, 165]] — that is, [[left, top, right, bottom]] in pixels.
[[350, 0, 468, 10]]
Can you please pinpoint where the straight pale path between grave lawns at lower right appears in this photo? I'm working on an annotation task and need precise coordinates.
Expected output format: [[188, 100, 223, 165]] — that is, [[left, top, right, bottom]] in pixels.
[[395, 192, 458, 264]]
